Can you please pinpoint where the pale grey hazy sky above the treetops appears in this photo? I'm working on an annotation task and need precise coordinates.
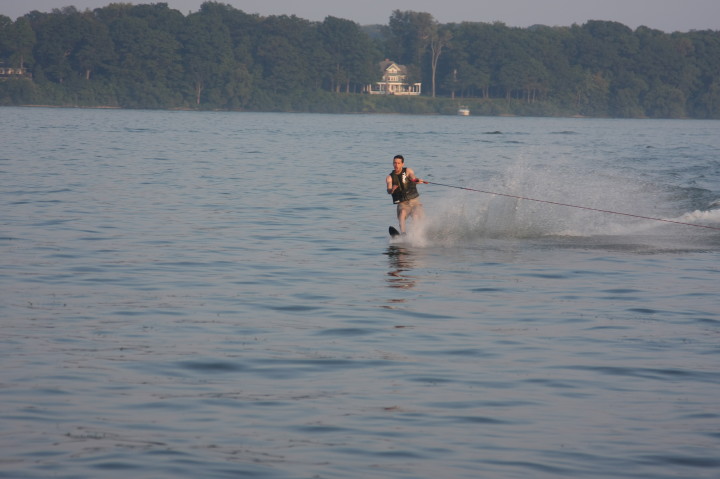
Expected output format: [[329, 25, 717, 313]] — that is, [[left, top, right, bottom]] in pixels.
[[0, 0, 720, 32]]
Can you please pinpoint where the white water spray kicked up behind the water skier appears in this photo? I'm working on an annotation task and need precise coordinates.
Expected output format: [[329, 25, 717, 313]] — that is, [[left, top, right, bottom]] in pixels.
[[407, 161, 720, 246]]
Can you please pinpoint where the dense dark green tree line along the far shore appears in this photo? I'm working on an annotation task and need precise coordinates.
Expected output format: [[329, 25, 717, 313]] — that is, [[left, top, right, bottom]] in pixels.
[[0, 2, 720, 119]]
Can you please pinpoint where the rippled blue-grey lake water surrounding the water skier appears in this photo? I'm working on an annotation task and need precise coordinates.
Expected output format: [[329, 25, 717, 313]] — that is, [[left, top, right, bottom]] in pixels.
[[0, 108, 720, 479]]
